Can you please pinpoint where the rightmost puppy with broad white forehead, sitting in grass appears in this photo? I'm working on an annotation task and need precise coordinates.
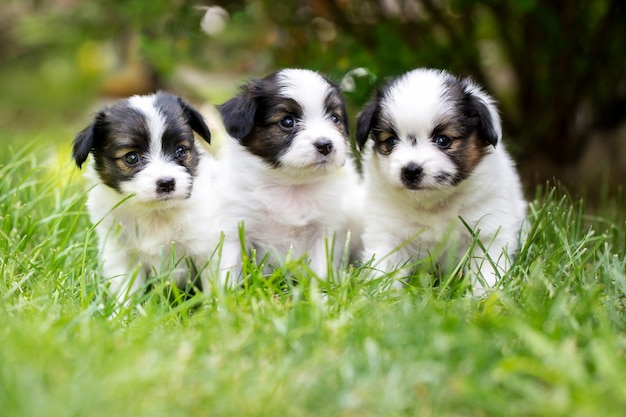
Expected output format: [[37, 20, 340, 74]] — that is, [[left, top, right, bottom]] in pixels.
[[356, 69, 527, 293]]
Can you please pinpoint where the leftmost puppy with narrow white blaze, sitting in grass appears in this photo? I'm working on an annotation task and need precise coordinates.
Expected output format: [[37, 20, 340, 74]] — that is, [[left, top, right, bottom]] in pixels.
[[73, 92, 213, 301]]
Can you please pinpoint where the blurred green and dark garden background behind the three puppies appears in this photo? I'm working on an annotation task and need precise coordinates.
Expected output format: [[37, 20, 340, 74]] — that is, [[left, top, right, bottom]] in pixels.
[[0, 0, 626, 194]]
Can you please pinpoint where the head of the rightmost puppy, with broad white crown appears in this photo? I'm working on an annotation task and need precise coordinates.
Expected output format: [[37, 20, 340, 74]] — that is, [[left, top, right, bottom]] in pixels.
[[356, 69, 502, 190]]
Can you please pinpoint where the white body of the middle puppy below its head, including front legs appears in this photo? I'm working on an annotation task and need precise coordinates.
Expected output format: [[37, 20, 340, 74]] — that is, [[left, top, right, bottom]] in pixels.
[[210, 143, 358, 285]]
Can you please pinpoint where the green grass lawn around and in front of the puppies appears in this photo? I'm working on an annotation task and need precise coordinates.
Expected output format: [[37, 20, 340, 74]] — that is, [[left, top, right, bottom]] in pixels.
[[0, 139, 626, 417]]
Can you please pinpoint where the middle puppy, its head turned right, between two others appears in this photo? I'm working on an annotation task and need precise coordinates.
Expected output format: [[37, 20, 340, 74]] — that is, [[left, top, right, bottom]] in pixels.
[[216, 69, 359, 285]]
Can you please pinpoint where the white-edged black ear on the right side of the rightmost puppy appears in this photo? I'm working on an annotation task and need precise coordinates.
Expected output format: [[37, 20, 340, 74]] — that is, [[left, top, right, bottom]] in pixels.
[[465, 80, 502, 147]]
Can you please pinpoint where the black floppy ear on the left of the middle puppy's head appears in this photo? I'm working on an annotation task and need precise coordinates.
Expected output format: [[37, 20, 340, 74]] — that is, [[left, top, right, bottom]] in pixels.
[[217, 86, 256, 141]]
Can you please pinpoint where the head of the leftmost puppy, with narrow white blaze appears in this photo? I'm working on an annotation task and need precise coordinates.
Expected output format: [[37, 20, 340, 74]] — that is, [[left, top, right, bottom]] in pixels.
[[72, 92, 211, 202]]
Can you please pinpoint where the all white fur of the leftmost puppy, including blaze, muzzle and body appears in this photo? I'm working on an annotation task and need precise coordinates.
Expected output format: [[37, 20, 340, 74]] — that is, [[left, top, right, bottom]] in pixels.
[[81, 96, 215, 302]]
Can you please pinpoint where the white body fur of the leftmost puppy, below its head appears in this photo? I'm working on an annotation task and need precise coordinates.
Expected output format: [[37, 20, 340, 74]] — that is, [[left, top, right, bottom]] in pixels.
[[87, 154, 214, 301]]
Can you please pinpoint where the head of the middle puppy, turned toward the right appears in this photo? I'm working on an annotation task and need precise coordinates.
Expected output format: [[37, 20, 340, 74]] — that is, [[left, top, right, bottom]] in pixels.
[[219, 69, 348, 171]]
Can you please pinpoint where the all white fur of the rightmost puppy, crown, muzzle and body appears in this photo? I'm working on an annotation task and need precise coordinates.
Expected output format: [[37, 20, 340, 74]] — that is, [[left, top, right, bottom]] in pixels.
[[363, 70, 527, 293]]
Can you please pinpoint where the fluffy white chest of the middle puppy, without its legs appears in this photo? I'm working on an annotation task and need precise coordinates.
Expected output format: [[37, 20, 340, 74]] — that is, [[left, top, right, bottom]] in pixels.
[[219, 143, 357, 256]]
